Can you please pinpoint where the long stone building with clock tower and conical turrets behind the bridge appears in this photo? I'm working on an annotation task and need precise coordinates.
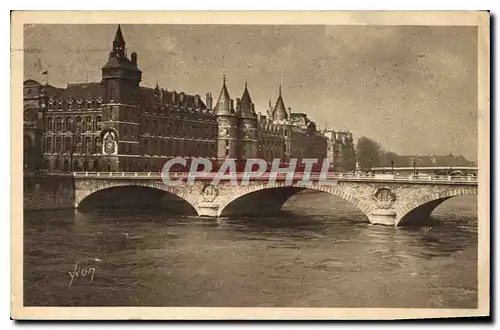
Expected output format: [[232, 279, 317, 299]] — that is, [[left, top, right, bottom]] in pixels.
[[24, 27, 354, 171]]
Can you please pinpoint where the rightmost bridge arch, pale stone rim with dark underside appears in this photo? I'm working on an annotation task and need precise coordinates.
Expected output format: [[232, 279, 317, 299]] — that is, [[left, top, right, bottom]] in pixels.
[[395, 187, 477, 226]]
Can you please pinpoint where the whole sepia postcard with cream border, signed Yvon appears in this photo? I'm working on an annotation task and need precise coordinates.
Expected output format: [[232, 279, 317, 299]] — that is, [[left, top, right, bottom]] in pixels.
[[11, 11, 490, 319]]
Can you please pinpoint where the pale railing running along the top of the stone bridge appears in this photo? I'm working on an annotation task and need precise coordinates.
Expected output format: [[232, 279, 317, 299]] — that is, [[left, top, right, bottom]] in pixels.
[[73, 172, 478, 183]]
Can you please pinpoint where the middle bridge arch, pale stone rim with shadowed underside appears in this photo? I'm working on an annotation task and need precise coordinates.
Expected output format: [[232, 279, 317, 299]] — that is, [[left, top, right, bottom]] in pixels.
[[218, 182, 373, 217]]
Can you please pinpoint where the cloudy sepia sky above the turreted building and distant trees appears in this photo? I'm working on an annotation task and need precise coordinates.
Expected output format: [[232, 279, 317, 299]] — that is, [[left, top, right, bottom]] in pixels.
[[24, 24, 478, 161]]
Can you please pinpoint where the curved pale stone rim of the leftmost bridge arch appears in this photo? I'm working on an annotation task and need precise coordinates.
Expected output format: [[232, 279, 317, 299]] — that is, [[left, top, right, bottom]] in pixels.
[[75, 180, 199, 215]]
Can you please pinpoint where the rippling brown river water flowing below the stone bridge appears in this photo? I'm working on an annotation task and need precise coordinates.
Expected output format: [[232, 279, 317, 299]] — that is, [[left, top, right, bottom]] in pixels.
[[24, 193, 478, 308]]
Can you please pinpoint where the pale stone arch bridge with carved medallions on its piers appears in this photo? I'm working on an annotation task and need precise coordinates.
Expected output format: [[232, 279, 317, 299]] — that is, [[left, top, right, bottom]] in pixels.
[[74, 172, 478, 226]]
